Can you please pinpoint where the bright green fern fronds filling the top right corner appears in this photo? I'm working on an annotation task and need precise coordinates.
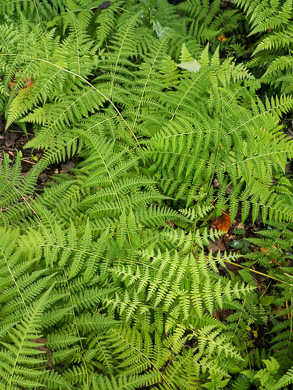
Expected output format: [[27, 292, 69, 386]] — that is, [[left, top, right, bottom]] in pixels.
[[234, 0, 293, 94]]
